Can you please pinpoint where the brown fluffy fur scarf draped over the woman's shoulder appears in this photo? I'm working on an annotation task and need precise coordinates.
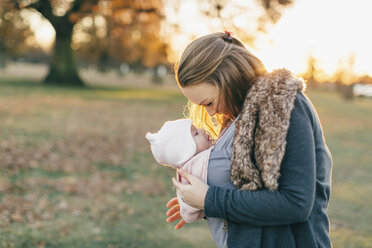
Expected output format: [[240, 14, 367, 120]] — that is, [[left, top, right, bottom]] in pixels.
[[231, 69, 305, 190]]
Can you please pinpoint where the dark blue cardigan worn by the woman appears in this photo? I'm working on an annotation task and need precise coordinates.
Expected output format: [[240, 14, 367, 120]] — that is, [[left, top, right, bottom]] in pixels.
[[204, 92, 332, 248]]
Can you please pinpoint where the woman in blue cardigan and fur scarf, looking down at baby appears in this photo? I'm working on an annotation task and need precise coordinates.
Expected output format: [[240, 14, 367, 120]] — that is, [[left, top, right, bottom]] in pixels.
[[167, 32, 332, 248]]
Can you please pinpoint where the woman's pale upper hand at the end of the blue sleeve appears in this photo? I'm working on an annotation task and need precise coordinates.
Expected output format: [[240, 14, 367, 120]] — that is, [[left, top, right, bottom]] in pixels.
[[172, 170, 209, 209]]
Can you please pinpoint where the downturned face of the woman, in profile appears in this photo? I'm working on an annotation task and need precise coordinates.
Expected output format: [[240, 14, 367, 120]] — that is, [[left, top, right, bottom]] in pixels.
[[181, 83, 226, 116]]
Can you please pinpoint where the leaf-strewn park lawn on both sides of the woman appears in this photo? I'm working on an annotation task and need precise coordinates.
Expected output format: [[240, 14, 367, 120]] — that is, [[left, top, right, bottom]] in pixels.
[[0, 79, 372, 247]]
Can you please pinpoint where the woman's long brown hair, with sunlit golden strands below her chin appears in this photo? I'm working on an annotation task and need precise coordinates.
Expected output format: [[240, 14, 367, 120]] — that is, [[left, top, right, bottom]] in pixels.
[[175, 33, 266, 138]]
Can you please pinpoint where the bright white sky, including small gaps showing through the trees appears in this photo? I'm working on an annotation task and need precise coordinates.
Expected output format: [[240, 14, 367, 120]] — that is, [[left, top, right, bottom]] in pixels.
[[26, 0, 372, 80]]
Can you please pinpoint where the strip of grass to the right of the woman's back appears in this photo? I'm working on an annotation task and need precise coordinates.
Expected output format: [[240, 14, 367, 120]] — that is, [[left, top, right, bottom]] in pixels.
[[309, 89, 372, 247]]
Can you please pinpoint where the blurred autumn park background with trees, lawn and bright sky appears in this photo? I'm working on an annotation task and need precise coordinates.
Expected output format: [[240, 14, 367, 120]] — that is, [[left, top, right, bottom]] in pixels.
[[0, 0, 372, 248]]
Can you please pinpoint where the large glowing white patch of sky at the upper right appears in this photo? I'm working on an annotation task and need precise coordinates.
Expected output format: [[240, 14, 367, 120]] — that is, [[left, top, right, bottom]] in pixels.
[[255, 0, 372, 80]]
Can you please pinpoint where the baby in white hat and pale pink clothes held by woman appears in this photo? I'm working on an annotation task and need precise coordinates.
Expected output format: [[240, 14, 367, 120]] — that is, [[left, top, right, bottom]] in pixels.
[[146, 119, 212, 223]]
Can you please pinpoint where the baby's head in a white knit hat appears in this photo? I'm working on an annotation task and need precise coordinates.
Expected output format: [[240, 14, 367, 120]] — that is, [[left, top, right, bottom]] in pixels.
[[146, 119, 212, 166]]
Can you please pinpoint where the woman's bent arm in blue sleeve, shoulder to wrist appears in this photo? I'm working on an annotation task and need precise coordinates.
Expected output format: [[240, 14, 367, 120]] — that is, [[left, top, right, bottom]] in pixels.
[[204, 97, 316, 226]]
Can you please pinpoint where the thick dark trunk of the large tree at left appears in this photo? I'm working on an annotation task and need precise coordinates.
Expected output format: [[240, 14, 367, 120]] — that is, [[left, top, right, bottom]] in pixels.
[[44, 21, 84, 86]]
